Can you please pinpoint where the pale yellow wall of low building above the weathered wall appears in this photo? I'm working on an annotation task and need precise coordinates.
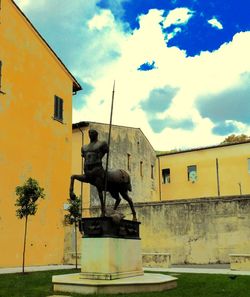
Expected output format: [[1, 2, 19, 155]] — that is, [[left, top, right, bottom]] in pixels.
[[158, 143, 250, 200]]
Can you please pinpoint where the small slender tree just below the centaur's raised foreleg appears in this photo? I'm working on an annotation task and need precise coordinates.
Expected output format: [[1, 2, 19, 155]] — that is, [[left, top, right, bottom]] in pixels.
[[64, 197, 81, 269]]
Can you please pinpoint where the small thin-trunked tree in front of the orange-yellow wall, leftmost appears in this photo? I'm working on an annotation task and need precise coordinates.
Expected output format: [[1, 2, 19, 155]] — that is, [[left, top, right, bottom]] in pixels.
[[15, 177, 45, 273]]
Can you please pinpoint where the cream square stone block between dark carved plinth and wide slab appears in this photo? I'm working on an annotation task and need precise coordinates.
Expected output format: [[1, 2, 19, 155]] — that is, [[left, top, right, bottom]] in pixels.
[[81, 237, 143, 280]]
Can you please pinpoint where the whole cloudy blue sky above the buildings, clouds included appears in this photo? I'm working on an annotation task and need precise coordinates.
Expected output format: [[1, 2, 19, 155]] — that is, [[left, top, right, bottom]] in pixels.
[[16, 0, 250, 150]]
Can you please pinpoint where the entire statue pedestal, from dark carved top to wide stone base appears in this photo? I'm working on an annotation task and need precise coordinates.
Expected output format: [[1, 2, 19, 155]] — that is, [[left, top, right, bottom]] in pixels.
[[52, 217, 177, 294]]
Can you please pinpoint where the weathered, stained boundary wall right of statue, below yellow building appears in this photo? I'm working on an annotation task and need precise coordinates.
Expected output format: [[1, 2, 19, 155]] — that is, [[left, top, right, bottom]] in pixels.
[[92, 195, 250, 264]]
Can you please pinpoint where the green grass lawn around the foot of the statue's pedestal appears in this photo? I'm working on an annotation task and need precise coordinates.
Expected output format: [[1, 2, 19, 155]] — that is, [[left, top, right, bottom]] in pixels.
[[0, 270, 250, 297]]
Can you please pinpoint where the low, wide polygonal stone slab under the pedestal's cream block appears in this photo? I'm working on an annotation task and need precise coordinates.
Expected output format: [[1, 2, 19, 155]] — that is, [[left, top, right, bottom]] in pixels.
[[52, 273, 177, 294]]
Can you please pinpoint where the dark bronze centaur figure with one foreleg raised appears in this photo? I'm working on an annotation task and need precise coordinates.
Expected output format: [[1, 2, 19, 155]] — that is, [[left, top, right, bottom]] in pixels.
[[70, 129, 136, 221]]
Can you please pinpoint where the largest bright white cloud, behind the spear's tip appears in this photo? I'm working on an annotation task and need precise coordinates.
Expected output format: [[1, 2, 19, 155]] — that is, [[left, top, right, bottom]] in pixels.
[[74, 10, 250, 150]]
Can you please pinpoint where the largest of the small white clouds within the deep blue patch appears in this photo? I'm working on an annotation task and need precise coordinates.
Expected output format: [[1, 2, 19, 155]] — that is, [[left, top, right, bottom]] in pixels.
[[163, 7, 194, 28]]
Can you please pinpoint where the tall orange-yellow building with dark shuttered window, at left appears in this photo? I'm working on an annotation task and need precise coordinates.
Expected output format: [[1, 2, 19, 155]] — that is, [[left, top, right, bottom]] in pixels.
[[0, 0, 81, 267]]
